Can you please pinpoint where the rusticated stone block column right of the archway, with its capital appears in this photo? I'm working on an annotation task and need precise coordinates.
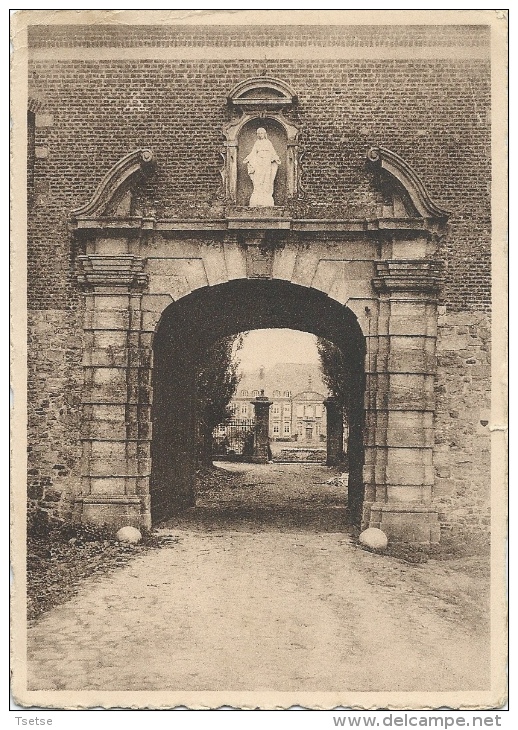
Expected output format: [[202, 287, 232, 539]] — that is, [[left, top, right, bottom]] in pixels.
[[364, 259, 441, 543]]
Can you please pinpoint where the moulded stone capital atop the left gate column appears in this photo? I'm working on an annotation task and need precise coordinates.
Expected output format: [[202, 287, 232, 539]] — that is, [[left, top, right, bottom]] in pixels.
[[77, 254, 148, 291]]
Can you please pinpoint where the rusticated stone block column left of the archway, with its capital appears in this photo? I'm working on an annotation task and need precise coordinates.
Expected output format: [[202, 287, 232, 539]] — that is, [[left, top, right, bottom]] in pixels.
[[75, 254, 151, 527]]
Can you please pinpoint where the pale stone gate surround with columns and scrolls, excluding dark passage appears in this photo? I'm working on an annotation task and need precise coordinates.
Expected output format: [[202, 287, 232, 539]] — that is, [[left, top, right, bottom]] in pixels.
[[70, 142, 447, 543]]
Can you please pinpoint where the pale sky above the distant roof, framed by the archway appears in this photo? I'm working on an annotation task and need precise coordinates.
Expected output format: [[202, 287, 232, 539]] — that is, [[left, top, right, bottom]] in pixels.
[[238, 329, 320, 371]]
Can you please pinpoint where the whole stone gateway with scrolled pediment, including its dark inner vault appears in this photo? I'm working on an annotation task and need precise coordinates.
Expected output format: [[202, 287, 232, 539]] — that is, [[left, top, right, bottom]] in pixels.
[[71, 148, 446, 543]]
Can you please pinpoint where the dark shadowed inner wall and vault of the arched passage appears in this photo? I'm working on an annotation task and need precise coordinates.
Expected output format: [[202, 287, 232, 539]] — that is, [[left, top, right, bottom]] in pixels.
[[151, 279, 365, 523]]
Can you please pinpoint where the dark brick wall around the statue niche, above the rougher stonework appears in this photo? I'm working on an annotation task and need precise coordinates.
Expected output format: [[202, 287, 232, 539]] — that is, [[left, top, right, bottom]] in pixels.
[[29, 32, 490, 311]]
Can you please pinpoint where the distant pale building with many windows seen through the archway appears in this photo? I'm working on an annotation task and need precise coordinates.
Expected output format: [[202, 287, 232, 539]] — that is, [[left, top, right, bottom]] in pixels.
[[230, 363, 328, 444]]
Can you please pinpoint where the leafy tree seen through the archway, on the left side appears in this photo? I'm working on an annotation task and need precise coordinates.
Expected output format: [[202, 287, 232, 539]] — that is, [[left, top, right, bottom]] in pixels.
[[196, 335, 243, 466]]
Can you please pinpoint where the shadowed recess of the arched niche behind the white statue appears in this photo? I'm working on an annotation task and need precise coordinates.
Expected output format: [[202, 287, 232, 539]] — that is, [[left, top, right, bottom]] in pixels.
[[236, 117, 288, 206]]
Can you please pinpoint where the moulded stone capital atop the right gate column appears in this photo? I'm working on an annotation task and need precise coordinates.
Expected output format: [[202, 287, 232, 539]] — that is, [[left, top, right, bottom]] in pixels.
[[372, 259, 443, 294]]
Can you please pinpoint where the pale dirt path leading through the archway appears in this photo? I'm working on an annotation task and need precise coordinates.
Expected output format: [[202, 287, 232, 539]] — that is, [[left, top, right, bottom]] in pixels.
[[29, 465, 489, 691]]
